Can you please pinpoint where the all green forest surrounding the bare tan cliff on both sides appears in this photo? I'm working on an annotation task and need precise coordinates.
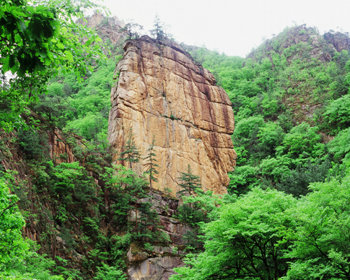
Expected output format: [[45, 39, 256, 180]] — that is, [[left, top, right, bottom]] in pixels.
[[0, 0, 350, 280]]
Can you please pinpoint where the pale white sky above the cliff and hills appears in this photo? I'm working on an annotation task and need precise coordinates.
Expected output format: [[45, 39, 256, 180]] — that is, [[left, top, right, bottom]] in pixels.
[[100, 0, 350, 56]]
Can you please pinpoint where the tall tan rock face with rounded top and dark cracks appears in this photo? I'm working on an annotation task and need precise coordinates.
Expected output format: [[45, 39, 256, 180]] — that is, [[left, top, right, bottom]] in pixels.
[[109, 36, 236, 195]]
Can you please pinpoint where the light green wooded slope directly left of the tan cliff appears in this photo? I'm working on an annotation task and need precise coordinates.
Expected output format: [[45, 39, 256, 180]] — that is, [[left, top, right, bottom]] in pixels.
[[32, 56, 121, 143]]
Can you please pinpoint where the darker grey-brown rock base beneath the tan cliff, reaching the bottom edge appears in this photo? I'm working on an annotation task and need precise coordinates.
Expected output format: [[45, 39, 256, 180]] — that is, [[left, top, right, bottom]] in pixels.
[[127, 191, 186, 280]]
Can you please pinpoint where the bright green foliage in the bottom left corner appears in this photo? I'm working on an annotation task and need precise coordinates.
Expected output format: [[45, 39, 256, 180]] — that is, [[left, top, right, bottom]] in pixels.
[[0, 174, 63, 280]]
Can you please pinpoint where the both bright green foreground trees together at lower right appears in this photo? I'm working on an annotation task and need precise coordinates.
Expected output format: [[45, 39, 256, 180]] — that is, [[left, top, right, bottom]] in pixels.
[[171, 171, 350, 280]]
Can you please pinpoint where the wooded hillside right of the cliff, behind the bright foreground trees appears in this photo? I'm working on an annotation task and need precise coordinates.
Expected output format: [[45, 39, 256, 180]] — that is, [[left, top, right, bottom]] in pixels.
[[193, 25, 350, 196]]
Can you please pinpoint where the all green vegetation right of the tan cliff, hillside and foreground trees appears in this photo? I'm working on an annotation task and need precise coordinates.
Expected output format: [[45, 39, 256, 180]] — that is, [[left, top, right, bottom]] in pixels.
[[172, 26, 350, 279]]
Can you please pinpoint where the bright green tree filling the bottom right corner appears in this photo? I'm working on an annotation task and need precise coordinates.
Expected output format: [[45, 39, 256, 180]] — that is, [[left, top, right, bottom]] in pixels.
[[285, 172, 350, 279]]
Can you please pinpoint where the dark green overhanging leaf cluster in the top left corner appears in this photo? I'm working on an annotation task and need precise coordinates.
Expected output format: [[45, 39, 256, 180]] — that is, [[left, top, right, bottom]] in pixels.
[[0, 2, 58, 76]]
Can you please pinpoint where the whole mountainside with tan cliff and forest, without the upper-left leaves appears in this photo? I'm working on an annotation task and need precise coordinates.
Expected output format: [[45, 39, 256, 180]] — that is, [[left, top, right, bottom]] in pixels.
[[0, 9, 350, 280]]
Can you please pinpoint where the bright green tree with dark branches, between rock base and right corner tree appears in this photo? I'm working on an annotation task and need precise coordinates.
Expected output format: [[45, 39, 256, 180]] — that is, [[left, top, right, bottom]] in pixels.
[[171, 188, 296, 280]]
